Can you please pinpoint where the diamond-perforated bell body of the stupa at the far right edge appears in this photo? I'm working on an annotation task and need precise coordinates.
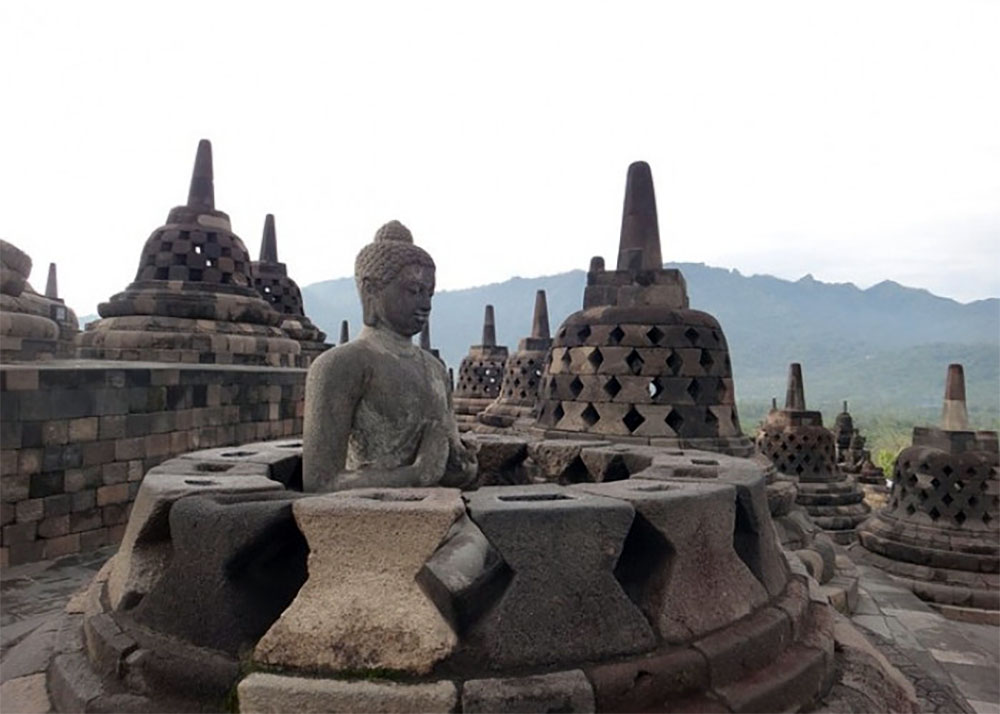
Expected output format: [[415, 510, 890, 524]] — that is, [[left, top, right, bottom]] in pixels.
[[886, 446, 1000, 533]]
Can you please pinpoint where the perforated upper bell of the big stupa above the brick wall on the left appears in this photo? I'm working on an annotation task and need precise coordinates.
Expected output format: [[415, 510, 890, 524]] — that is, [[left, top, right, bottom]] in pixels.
[[136, 228, 252, 287]]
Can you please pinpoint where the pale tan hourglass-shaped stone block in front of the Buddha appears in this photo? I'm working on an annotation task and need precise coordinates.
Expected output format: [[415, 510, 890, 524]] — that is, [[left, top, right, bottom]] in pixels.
[[254, 488, 464, 674]]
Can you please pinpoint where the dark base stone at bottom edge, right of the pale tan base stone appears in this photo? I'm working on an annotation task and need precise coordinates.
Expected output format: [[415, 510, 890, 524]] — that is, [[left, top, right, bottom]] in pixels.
[[462, 669, 594, 714]]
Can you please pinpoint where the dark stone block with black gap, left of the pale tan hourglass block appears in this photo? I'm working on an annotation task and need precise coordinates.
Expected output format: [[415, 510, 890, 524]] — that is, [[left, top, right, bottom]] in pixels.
[[133, 492, 308, 655]]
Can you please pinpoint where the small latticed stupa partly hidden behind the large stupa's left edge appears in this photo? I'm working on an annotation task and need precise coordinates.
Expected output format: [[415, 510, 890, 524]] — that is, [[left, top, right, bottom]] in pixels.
[[479, 290, 552, 427]]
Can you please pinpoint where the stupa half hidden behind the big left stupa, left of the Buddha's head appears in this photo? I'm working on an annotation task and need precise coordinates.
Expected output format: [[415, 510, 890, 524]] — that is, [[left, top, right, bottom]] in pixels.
[[250, 213, 331, 367]]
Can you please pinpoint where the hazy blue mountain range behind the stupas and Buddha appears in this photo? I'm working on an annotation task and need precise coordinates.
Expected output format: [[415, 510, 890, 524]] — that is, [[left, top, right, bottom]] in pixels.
[[302, 263, 1000, 419]]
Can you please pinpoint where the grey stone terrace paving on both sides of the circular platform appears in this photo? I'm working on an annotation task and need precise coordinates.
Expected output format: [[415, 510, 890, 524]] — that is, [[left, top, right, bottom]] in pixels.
[[0, 547, 1000, 714]]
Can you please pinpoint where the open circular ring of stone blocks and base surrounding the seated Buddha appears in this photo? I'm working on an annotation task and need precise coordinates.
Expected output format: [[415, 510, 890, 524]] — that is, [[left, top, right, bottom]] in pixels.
[[49, 435, 856, 712]]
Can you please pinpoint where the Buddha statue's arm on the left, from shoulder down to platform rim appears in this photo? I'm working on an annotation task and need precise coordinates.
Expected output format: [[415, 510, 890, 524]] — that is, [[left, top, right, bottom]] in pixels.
[[302, 349, 367, 492]]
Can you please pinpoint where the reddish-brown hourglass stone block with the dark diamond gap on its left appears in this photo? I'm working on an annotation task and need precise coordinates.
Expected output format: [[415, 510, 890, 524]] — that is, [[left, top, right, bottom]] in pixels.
[[573, 479, 767, 643]]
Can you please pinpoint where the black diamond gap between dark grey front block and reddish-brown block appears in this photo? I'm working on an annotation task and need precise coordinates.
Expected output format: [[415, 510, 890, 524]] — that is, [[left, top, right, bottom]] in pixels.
[[615, 513, 675, 622]]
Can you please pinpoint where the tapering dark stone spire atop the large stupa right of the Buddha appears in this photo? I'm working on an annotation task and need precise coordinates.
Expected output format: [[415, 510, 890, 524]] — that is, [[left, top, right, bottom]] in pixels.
[[618, 161, 663, 270]]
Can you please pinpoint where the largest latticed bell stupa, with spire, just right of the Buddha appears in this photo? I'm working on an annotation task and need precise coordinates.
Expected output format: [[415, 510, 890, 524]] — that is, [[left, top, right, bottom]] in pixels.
[[537, 161, 753, 456]]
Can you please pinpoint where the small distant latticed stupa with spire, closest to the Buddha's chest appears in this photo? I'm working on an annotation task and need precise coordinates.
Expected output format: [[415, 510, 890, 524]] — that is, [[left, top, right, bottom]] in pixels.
[[452, 305, 507, 431]]
